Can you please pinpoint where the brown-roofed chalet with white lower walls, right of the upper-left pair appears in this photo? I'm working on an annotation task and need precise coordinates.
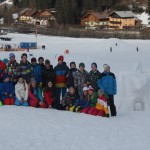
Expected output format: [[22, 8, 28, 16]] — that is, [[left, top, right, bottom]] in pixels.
[[33, 9, 56, 26]]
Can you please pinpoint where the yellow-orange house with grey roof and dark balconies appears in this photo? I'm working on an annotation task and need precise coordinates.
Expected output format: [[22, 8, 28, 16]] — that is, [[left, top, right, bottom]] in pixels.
[[109, 11, 135, 29]]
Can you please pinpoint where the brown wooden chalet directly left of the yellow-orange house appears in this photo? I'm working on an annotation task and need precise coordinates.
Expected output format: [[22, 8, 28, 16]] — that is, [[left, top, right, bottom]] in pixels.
[[81, 12, 109, 29]]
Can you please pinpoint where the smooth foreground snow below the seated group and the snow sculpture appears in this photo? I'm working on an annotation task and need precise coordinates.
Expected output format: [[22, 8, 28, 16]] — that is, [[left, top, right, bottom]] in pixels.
[[0, 106, 150, 150]]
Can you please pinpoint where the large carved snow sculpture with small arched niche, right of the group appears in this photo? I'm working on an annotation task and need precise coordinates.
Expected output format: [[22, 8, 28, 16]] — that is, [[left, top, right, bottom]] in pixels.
[[117, 64, 150, 111]]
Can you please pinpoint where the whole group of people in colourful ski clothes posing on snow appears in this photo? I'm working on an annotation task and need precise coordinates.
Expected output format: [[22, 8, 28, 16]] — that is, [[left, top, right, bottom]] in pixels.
[[0, 53, 117, 117]]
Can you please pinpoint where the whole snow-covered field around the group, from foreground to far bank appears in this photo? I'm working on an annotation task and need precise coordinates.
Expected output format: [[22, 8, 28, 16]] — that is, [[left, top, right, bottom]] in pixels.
[[0, 34, 150, 150]]
